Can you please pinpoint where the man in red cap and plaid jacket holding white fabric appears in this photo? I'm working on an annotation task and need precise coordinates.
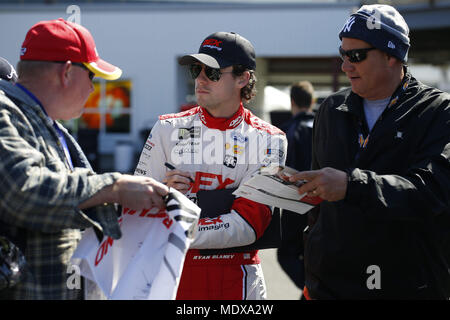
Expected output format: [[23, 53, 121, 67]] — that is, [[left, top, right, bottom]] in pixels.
[[0, 19, 168, 299]]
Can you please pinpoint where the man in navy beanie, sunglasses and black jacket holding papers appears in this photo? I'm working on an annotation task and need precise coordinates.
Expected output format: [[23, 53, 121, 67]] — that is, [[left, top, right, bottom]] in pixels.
[[291, 5, 450, 299]]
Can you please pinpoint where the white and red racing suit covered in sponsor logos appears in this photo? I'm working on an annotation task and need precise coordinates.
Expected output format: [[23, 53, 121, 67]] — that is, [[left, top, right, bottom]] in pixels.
[[135, 104, 287, 300]]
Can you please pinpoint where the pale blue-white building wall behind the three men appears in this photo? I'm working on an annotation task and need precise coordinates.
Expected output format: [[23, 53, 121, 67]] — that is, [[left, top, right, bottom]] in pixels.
[[0, 4, 351, 152]]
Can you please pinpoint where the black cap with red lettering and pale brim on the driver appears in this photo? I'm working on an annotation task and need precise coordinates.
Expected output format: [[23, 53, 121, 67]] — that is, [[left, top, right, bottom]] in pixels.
[[178, 32, 256, 70]]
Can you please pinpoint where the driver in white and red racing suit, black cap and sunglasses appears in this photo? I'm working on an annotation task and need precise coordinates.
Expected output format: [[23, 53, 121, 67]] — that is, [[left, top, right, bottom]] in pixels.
[[135, 32, 287, 300]]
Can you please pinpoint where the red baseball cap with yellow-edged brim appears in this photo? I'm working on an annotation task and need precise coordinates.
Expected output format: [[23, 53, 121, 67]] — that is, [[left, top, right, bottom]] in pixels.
[[20, 18, 122, 80]]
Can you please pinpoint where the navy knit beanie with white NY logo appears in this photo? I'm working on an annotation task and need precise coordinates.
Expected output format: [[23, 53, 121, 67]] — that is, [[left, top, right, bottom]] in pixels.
[[339, 4, 410, 62]]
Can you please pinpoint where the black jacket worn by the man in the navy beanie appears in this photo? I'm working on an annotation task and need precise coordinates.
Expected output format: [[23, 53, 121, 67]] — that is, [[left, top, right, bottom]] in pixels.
[[305, 73, 450, 299]]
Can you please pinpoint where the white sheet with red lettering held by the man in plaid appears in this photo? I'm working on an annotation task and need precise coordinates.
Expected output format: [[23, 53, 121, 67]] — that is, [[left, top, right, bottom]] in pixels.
[[72, 189, 200, 300]]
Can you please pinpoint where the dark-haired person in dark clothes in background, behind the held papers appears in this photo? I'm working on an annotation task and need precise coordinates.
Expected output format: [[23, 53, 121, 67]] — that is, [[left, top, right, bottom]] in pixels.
[[277, 81, 315, 298]]
